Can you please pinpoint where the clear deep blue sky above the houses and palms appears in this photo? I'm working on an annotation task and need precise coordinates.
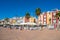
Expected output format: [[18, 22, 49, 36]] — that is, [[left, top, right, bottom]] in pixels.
[[0, 0, 60, 19]]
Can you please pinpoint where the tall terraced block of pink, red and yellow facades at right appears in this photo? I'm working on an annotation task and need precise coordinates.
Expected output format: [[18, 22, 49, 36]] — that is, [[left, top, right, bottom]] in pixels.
[[38, 10, 59, 26]]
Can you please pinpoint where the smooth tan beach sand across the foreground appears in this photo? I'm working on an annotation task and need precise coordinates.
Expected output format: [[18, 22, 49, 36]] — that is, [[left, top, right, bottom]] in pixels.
[[0, 27, 60, 40]]
